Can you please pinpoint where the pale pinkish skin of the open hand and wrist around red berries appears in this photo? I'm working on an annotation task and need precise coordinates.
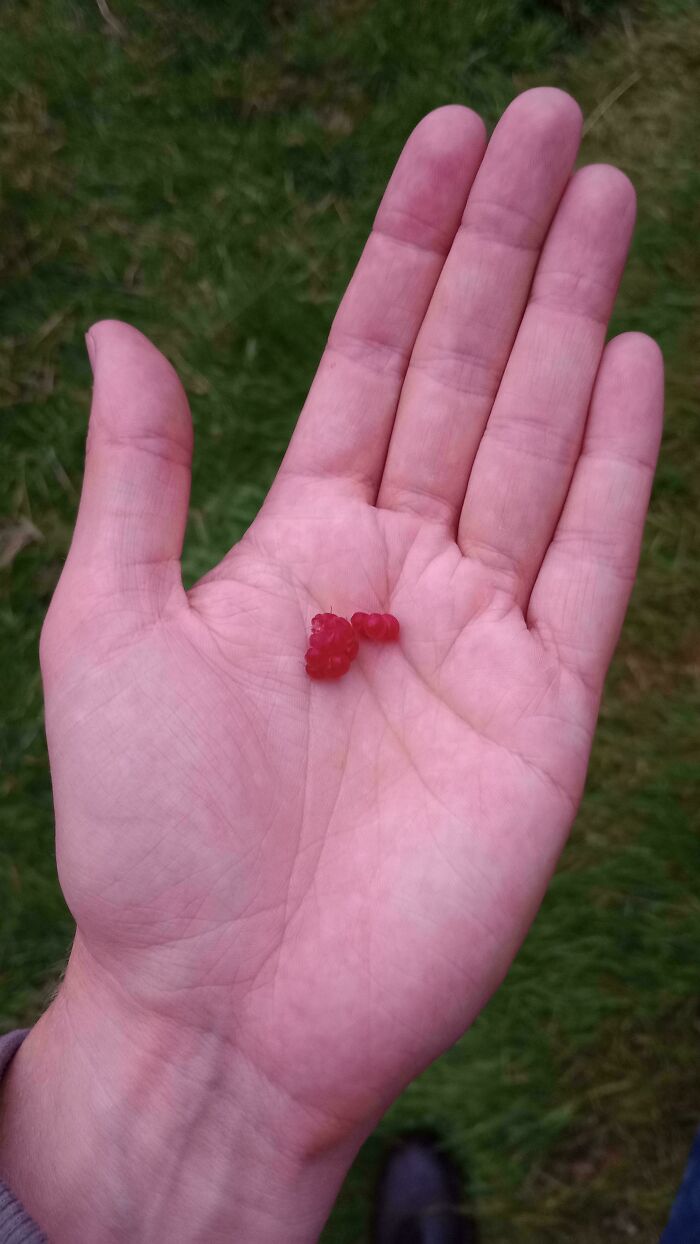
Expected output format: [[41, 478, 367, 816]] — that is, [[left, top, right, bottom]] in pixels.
[[0, 88, 663, 1244]]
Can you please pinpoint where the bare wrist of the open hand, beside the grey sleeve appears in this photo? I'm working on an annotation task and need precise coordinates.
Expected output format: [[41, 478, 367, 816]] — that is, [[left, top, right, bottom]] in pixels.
[[0, 943, 363, 1244]]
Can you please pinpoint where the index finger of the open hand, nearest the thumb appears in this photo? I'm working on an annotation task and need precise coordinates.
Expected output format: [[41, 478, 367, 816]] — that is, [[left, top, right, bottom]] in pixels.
[[274, 104, 486, 501]]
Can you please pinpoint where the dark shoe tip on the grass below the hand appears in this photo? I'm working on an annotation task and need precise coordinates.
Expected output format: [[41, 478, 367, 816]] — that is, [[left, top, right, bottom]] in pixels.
[[372, 1133, 477, 1244]]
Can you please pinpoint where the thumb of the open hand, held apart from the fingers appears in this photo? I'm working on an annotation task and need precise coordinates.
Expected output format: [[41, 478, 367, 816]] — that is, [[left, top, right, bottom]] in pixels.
[[66, 320, 193, 611]]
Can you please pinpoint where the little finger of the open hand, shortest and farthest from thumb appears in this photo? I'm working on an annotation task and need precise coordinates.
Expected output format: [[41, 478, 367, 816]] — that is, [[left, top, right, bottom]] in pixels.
[[527, 332, 664, 694]]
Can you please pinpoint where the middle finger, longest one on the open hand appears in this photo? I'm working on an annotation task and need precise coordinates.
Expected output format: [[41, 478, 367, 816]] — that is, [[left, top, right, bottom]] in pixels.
[[377, 87, 581, 530]]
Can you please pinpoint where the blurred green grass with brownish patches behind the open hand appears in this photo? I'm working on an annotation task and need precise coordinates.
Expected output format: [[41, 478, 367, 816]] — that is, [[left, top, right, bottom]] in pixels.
[[0, 0, 700, 1244]]
